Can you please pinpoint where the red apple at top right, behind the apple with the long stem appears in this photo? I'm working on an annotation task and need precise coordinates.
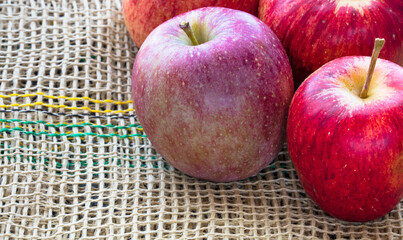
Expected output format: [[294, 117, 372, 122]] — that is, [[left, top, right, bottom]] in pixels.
[[259, 0, 403, 88]]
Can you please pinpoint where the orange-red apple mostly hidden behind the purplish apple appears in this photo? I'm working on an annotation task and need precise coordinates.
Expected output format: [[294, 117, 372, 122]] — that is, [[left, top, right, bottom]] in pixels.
[[123, 0, 259, 47]]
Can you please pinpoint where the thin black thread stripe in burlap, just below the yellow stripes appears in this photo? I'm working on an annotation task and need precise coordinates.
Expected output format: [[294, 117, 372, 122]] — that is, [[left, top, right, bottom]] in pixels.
[[0, 108, 137, 119]]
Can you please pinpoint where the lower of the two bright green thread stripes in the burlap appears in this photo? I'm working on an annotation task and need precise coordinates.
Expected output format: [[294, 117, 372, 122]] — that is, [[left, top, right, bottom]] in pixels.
[[0, 127, 147, 138]]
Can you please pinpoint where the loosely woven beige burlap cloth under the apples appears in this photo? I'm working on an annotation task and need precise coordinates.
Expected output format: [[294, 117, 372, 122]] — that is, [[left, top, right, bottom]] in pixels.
[[0, 0, 403, 239]]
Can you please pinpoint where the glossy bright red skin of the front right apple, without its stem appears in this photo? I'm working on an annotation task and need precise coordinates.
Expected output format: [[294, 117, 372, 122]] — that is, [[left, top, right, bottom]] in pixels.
[[287, 56, 403, 222]]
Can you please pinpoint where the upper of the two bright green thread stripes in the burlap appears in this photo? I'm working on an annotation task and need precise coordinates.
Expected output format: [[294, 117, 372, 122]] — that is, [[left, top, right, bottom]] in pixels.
[[0, 118, 143, 130]]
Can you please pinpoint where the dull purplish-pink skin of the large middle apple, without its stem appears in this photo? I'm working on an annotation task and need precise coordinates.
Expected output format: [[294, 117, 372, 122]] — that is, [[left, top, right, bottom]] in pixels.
[[132, 7, 293, 182]]
